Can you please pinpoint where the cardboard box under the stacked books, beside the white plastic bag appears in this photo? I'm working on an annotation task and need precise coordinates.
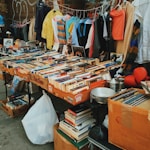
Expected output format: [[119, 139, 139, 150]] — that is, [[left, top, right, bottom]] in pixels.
[[54, 124, 89, 150]]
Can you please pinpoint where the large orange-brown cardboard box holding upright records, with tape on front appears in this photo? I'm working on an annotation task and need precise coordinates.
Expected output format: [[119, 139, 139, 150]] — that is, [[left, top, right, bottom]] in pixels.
[[108, 89, 150, 150]]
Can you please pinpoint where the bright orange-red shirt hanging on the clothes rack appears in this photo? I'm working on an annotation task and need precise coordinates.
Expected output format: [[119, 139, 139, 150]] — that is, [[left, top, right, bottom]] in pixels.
[[110, 9, 125, 40]]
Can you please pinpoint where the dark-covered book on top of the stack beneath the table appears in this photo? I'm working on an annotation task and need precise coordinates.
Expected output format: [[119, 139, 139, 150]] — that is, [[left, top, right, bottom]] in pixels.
[[67, 104, 91, 116]]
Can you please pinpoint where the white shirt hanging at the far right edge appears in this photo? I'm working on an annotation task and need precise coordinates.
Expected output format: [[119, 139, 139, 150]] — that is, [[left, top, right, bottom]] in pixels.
[[133, 0, 150, 64]]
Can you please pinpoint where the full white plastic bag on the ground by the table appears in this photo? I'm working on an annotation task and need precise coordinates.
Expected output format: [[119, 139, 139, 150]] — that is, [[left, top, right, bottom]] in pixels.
[[22, 92, 58, 144]]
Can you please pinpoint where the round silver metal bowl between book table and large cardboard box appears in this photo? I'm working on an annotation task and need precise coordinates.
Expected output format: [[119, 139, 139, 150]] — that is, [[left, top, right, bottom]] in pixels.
[[90, 87, 116, 104]]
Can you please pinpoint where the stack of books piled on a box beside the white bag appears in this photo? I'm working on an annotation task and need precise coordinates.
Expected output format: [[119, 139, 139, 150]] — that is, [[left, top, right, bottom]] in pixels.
[[59, 104, 96, 142]]
